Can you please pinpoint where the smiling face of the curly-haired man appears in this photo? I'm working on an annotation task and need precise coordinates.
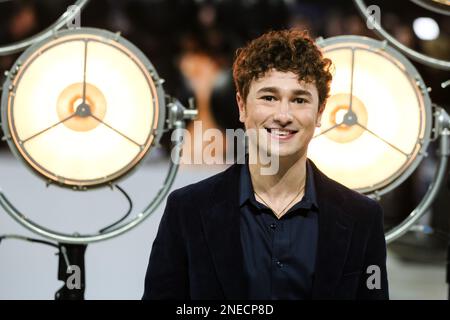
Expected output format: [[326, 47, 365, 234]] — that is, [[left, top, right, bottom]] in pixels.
[[237, 69, 323, 158]]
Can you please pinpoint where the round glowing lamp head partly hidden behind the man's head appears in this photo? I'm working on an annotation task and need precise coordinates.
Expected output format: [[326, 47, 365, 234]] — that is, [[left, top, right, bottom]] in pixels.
[[308, 36, 431, 194]]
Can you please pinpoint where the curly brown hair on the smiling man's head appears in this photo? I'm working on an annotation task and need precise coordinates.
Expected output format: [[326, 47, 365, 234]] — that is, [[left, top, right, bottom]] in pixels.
[[233, 29, 332, 107]]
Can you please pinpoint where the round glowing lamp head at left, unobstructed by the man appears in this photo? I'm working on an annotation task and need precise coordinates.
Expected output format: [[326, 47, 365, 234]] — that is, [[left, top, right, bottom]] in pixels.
[[1, 28, 165, 189]]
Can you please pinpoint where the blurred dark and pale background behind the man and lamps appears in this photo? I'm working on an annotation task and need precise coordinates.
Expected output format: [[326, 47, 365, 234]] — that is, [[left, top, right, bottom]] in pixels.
[[0, 0, 450, 299]]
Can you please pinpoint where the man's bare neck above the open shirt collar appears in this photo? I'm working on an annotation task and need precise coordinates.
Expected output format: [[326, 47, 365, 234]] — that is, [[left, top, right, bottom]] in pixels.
[[249, 153, 306, 202]]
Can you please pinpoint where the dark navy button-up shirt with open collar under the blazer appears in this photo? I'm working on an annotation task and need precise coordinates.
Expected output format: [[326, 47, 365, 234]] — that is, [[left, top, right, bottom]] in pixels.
[[239, 158, 318, 300]]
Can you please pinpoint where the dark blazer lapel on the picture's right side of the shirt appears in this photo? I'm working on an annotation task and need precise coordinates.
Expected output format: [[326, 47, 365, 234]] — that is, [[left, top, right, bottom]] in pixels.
[[312, 164, 354, 299]]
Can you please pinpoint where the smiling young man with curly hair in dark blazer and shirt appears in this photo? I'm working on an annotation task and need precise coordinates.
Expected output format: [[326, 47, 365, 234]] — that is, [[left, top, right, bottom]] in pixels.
[[143, 30, 388, 299]]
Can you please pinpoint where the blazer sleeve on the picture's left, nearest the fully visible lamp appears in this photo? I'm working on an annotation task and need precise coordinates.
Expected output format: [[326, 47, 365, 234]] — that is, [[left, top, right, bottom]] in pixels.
[[142, 192, 189, 300]]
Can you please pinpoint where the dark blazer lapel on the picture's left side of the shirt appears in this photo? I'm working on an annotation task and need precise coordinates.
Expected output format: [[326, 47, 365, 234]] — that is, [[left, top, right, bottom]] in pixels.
[[202, 164, 247, 299]]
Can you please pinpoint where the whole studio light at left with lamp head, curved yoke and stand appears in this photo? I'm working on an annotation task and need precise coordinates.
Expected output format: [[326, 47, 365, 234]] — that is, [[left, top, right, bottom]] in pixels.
[[0, 28, 197, 300]]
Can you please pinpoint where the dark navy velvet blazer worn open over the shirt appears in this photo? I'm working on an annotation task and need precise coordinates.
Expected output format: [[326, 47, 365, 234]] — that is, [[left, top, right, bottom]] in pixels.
[[143, 162, 389, 300]]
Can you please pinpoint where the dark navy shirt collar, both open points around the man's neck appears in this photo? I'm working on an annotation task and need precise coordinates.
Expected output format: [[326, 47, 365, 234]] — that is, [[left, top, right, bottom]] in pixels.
[[239, 155, 319, 208]]
